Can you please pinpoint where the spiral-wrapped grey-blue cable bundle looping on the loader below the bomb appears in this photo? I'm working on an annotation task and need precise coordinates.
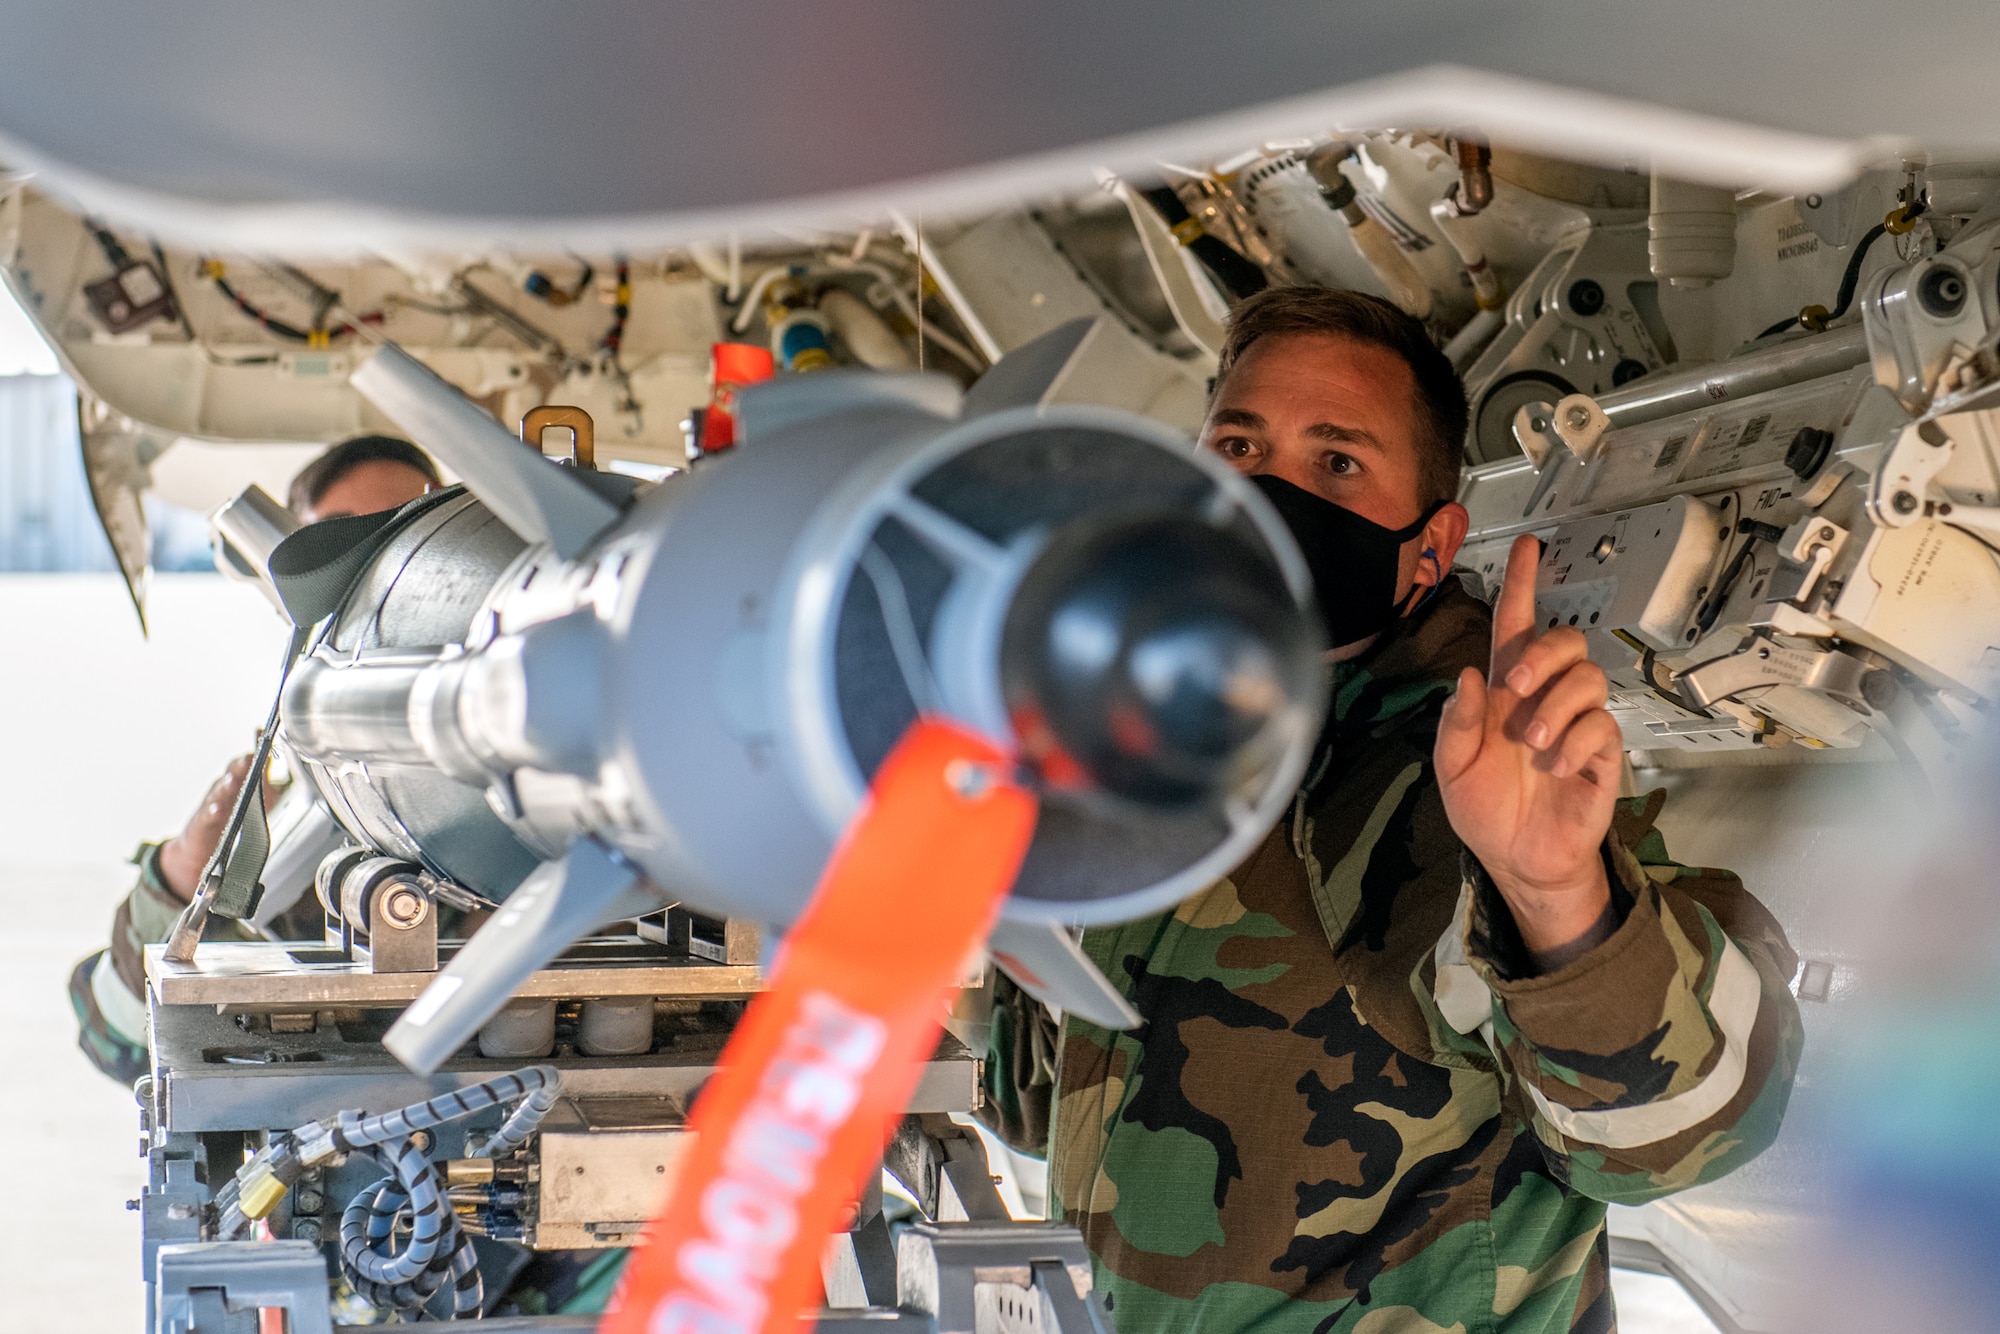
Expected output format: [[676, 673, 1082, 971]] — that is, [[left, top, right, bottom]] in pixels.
[[216, 1066, 562, 1320]]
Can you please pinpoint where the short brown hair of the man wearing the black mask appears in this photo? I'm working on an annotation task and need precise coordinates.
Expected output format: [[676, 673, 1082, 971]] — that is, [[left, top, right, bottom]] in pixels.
[[1210, 286, 1466, 506]]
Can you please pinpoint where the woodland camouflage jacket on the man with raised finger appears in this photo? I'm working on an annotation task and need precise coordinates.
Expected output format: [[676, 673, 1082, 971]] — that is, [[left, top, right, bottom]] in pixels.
[[986, 586, 1800, 1334]]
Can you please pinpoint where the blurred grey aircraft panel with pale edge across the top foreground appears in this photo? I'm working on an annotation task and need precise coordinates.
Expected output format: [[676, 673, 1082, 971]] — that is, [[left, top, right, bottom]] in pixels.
[[0, 0, 1968, 250]]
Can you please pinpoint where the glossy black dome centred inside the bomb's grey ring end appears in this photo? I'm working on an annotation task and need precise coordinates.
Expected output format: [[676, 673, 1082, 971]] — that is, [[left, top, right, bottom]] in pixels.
[[1000, 518, 1322, 806]]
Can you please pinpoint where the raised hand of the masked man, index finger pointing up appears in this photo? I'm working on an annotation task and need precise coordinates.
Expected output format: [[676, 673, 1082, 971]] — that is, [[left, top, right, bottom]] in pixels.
[[1436, 536, 1622, 954]]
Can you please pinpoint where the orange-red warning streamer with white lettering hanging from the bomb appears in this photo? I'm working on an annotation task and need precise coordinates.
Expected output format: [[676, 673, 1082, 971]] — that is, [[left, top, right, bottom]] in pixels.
[[600, 720, 1036, 1334]]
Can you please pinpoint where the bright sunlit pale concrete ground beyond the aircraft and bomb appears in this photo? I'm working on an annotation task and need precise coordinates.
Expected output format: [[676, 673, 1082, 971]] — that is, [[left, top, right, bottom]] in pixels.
[[0, 574, 1714, 1334]]
